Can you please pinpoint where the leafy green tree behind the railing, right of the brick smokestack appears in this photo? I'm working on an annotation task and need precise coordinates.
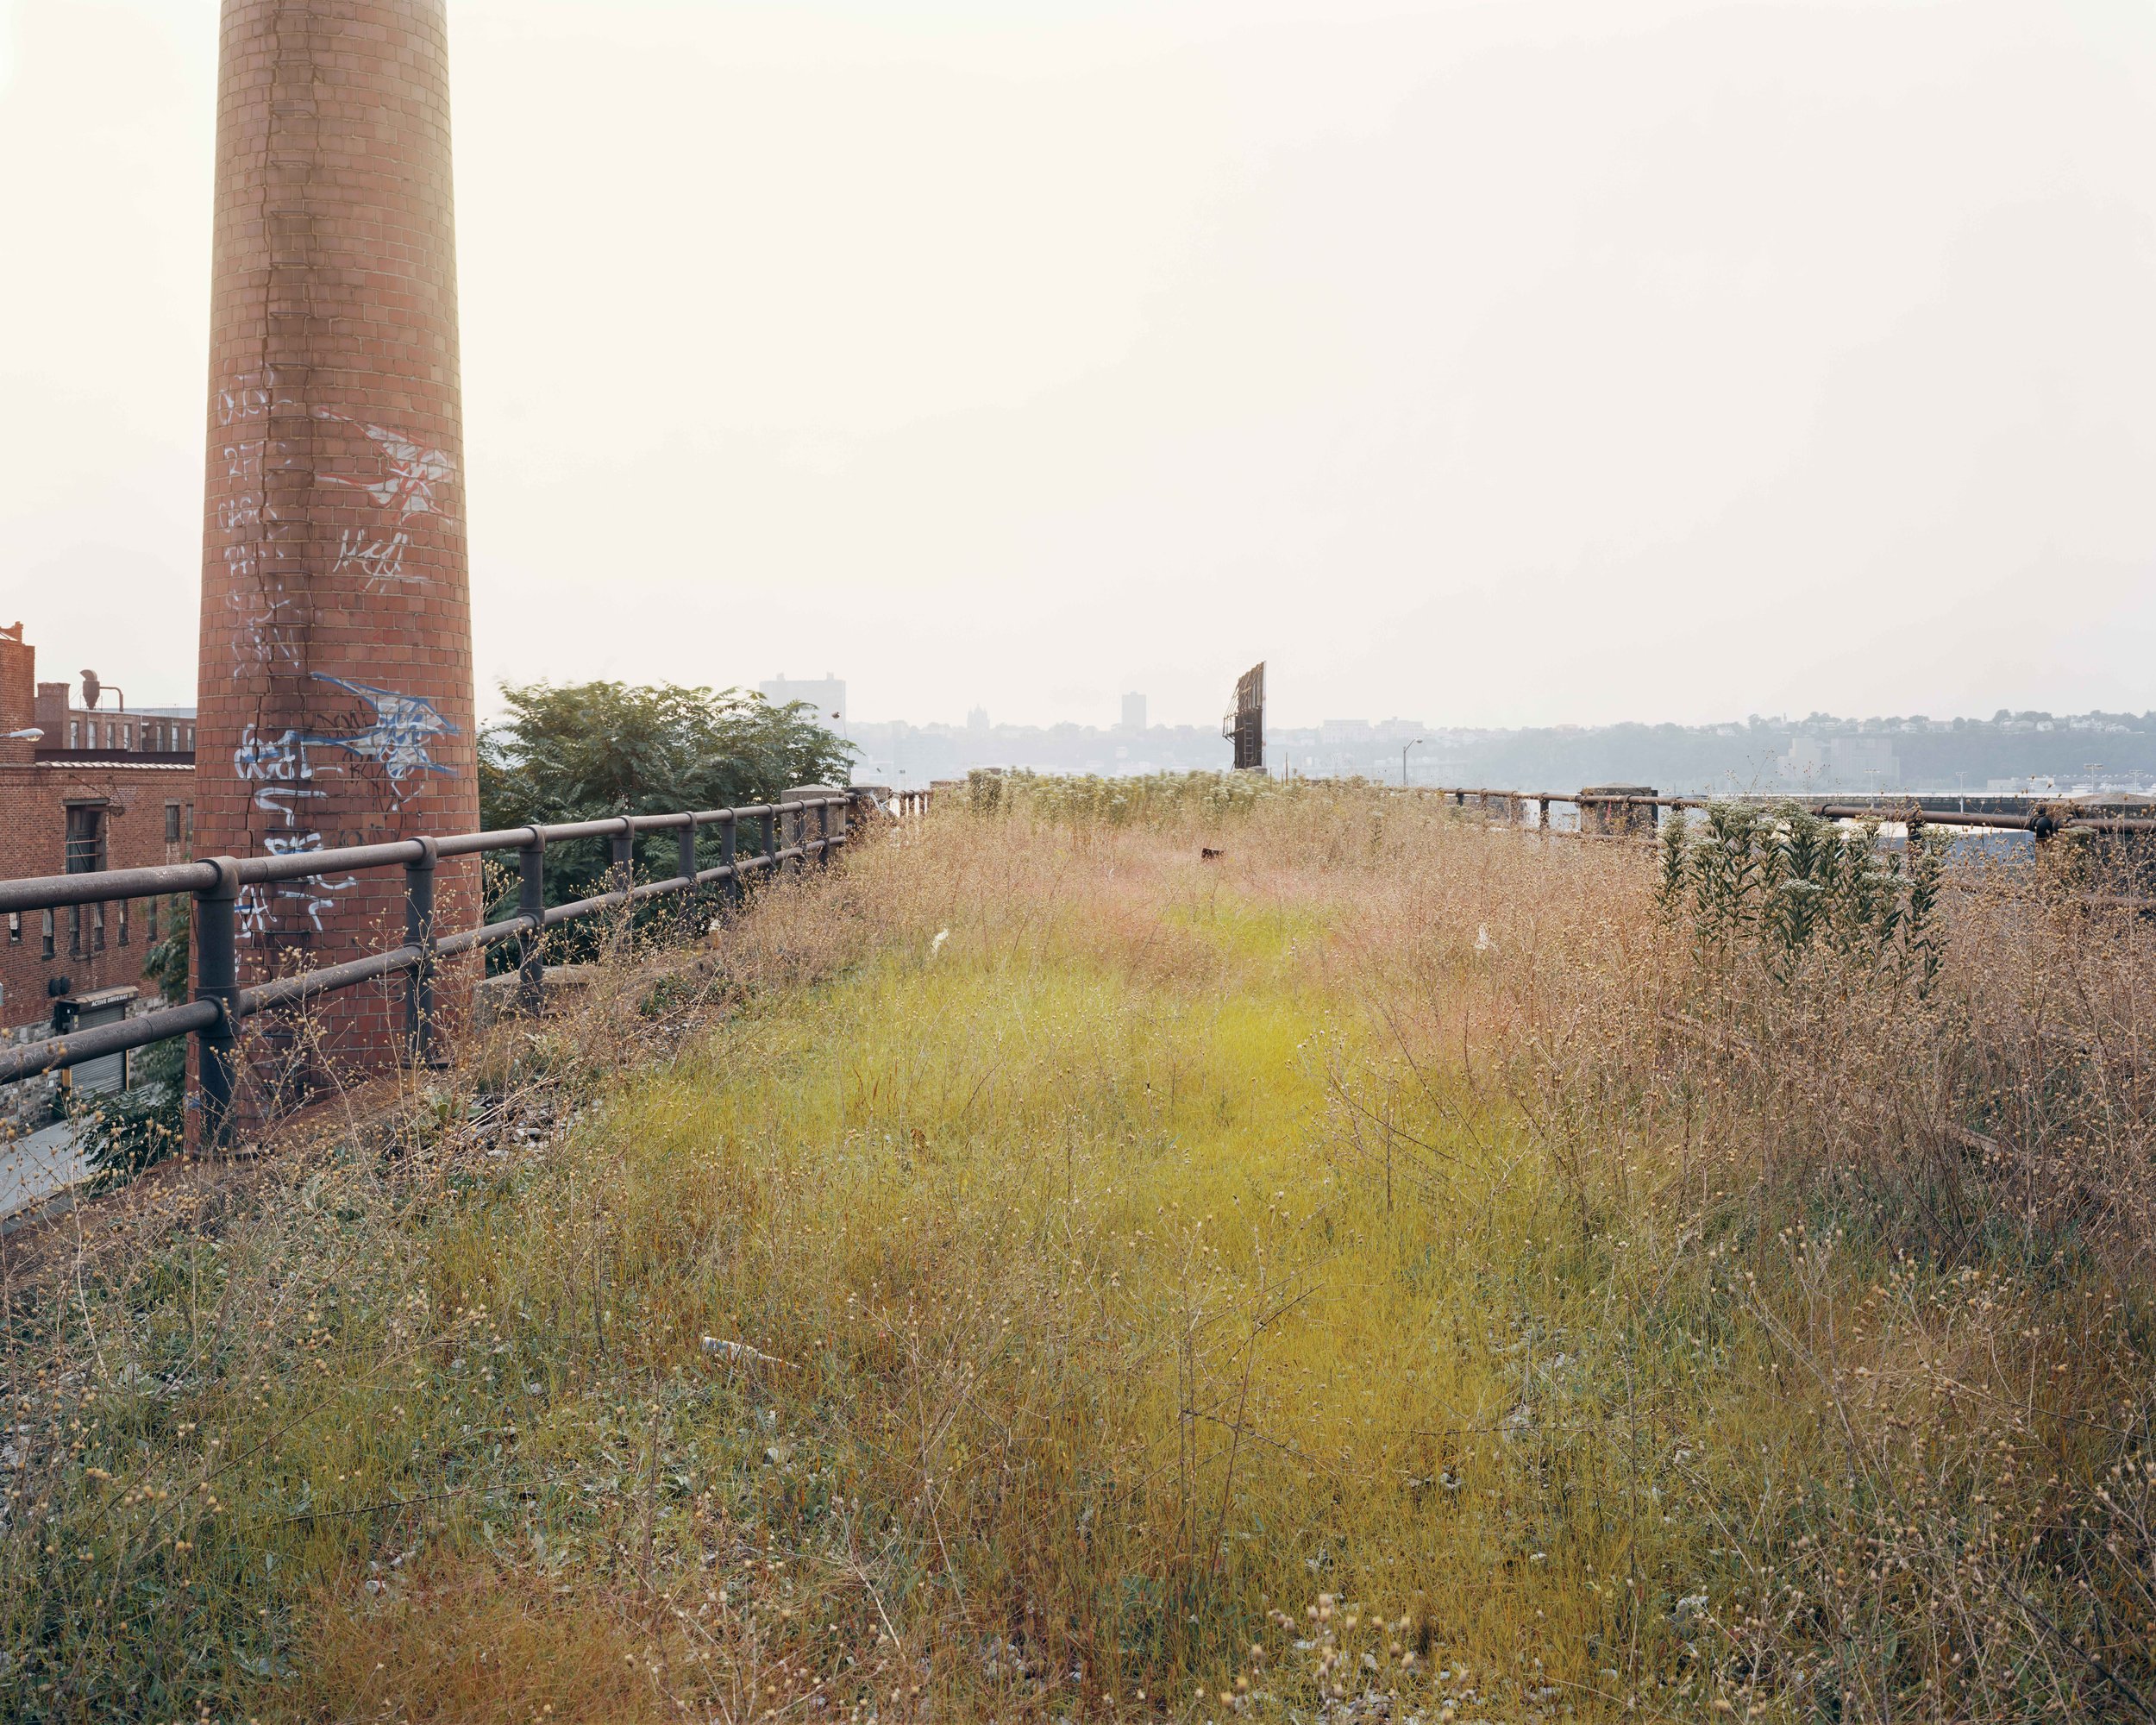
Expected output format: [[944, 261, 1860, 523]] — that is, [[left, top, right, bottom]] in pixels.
[[479, 681, 854, 936]]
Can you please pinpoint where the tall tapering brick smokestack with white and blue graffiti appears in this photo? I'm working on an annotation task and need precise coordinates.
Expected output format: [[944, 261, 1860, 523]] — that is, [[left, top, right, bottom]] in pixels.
[[197, 0, 479, 1087]]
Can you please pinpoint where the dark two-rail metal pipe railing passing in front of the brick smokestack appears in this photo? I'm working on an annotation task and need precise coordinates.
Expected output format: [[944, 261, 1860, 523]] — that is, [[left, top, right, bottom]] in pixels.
[[0, 792, 888, 1143]]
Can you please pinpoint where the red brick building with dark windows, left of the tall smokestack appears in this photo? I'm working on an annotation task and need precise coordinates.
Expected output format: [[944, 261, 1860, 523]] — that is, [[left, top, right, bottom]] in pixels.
[[0, 624, 194, 1113]]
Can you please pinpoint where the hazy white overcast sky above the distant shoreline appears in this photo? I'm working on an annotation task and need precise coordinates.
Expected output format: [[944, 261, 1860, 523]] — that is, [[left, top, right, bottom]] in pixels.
[[0, 0, 2156, 724]]
